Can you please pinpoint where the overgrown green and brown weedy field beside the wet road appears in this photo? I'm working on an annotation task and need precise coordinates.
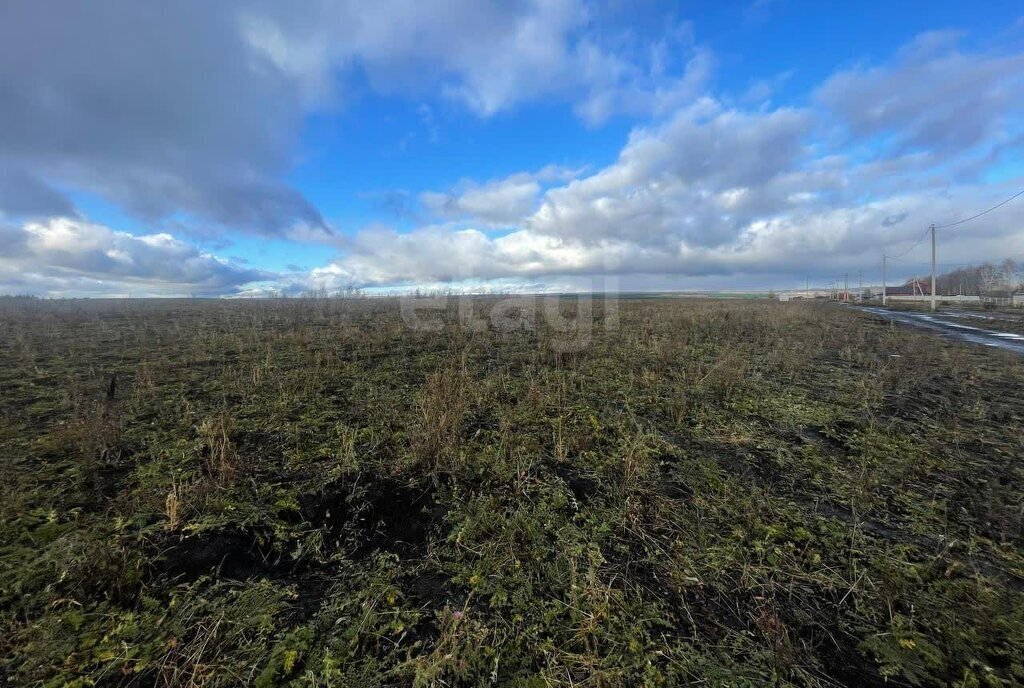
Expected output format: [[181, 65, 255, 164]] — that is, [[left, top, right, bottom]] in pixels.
[[0, 299, 1024, 687]]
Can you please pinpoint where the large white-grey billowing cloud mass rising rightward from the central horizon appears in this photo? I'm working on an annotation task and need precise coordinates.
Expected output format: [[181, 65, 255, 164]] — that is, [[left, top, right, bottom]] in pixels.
[[299, 37, 1024, 285]]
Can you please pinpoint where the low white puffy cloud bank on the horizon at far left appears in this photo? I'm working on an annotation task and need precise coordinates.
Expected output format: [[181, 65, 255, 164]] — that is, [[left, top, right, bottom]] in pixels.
[[0, 217, 276, 296]]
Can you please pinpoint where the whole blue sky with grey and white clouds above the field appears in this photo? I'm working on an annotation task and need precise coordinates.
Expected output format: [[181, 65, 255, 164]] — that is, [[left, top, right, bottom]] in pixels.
[[0, 0, 1024, 297]]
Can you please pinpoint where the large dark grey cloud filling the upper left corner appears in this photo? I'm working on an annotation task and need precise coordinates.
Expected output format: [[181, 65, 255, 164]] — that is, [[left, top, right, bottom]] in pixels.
[[0, 0, 323, 233]]
